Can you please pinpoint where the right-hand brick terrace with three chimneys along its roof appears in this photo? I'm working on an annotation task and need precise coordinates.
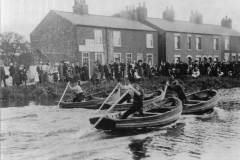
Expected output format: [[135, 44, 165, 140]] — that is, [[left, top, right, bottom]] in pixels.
[[143, 8, 240, 62]]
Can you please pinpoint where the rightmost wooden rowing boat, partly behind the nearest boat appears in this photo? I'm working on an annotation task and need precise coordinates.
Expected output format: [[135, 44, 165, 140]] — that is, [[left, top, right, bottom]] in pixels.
[[183, 89, 219, 114]]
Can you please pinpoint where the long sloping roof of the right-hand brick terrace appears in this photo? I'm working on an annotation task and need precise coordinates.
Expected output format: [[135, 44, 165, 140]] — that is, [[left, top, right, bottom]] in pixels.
[[147, 18, 240, 36]]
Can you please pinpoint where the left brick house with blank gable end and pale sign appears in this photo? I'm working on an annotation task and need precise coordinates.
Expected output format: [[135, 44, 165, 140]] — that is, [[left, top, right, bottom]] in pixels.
[[30, 0, 158, 75]]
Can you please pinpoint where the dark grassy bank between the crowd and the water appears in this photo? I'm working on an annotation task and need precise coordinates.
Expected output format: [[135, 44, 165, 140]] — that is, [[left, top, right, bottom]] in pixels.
[[0, 77, 240, 106]]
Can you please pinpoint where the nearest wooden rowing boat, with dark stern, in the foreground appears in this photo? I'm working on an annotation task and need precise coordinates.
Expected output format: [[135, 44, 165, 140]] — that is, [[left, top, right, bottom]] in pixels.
[[90, 97, 182, 130]]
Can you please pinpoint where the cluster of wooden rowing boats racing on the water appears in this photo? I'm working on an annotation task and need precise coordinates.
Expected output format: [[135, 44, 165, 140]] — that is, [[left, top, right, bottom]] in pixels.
[[59, 82, 218, 130]]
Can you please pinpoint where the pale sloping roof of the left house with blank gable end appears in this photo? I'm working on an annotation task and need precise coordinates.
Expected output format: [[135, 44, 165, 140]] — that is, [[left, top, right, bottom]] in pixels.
[[53, 11, 156, 31]]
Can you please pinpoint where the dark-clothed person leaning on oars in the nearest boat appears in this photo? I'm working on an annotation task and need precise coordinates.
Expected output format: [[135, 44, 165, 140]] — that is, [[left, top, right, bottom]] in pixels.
[[121, 80, 144, 119]]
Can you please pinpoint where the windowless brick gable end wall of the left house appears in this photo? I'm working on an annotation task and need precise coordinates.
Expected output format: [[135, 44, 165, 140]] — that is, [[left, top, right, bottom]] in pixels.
[[30, 12, 77, 61]]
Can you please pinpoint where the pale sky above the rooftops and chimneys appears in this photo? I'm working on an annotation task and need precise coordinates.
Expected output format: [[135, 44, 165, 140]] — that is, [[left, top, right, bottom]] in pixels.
[[0, 0, 240, 40]]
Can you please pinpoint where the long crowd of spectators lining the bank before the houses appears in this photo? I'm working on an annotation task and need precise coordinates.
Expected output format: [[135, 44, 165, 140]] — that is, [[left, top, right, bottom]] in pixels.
[[0, 57, 240, 86]]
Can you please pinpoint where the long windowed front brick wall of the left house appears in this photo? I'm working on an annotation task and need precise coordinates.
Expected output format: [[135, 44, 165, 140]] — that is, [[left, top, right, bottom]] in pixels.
[[75, 26, 158, 74]]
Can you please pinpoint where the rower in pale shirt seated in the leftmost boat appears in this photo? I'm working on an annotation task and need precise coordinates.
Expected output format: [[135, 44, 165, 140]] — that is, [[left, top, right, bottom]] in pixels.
[[69, 77, 85, 102]]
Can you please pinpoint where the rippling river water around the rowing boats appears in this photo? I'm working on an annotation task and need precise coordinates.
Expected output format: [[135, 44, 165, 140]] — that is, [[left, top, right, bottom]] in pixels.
[[0, 89, 240, 160]]
